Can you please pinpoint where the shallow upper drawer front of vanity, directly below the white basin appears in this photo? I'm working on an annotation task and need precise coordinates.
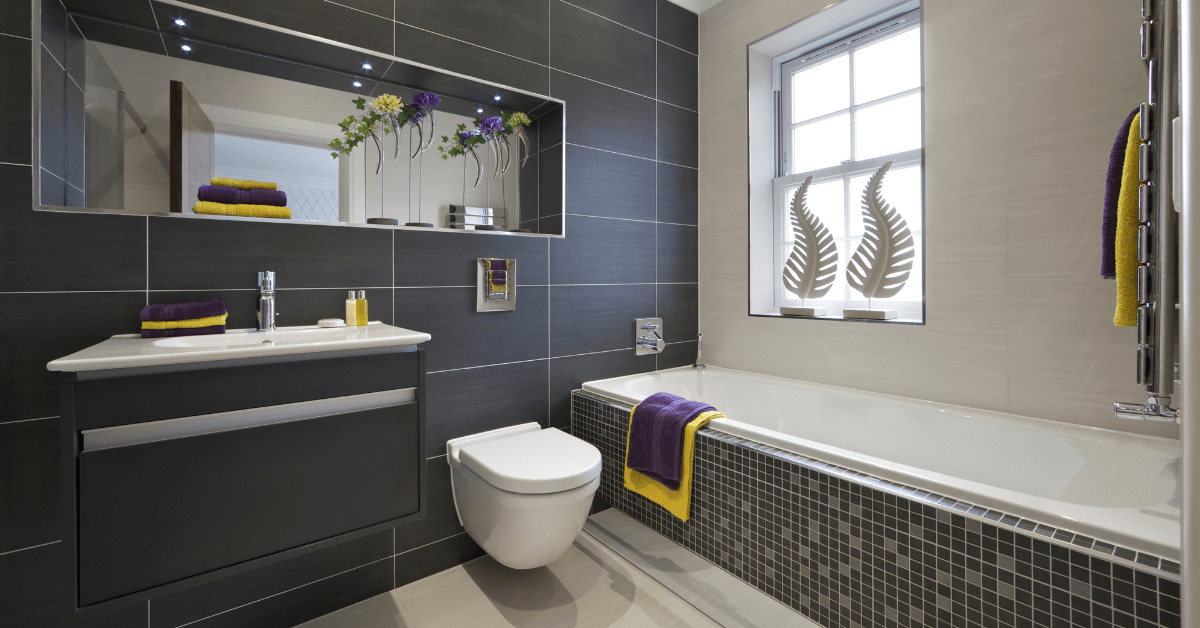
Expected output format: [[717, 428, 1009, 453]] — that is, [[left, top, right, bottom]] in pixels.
[[71, 351, 420, 430]]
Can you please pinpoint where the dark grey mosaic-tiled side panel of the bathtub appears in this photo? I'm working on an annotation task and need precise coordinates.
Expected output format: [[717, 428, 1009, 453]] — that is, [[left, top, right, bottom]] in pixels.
[[571, 390, 1180, 628]]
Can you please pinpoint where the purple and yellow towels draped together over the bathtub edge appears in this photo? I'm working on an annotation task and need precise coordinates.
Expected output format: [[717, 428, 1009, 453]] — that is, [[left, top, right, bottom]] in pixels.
[[625, 393, 724, 521]]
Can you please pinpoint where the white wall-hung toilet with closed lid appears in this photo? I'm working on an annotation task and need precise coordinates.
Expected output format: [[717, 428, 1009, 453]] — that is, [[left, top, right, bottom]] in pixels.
[[446, 423, 600, 569]]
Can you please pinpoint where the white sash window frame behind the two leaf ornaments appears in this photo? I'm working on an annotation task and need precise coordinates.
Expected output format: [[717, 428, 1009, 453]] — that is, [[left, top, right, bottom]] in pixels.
[[770, 6, 926, 324]]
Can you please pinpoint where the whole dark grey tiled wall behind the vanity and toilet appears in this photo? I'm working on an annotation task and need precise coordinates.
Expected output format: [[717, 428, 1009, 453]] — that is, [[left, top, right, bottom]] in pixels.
[[0, 0, 697, 628]]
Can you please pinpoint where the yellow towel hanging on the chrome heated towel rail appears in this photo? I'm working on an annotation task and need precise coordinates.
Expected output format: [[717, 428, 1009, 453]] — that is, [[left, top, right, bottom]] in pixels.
[[1112, 115, 1141, 327]]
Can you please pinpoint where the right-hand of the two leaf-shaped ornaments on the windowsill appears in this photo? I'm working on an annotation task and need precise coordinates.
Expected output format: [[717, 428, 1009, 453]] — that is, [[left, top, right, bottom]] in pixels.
[[846, 161, 916, 299]]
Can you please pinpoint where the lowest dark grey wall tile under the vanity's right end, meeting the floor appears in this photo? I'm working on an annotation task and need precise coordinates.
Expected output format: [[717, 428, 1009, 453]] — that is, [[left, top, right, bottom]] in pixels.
[[190, 558, 394, 628]]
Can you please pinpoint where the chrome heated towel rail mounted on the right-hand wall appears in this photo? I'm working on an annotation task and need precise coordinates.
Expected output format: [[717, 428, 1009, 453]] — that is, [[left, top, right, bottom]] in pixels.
[[1114, 0, 1180, 423]]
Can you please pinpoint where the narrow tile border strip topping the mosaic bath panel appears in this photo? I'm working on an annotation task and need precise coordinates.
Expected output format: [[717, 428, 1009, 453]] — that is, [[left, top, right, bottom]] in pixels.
[[575, 390, 1180, 580]]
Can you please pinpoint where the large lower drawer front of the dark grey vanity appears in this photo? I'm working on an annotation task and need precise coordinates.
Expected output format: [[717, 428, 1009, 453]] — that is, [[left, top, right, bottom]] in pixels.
[[78, 402, 422, 606]]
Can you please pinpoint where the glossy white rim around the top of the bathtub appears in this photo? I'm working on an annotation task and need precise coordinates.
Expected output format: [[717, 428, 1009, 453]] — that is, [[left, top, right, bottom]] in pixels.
[[576, 366, 1181, 578]]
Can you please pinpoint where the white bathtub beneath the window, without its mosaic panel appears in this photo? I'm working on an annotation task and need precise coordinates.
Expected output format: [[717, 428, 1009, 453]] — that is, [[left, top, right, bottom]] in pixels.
[[583, 366, 1180, 562]]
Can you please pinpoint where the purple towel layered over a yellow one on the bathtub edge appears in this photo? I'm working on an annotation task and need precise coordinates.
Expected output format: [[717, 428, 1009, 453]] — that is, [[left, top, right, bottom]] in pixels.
[[625, 393, 715, 491]]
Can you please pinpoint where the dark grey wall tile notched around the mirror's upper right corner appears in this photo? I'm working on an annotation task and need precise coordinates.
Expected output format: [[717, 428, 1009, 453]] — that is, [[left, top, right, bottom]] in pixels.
[[550, 71, 655, 160]]
